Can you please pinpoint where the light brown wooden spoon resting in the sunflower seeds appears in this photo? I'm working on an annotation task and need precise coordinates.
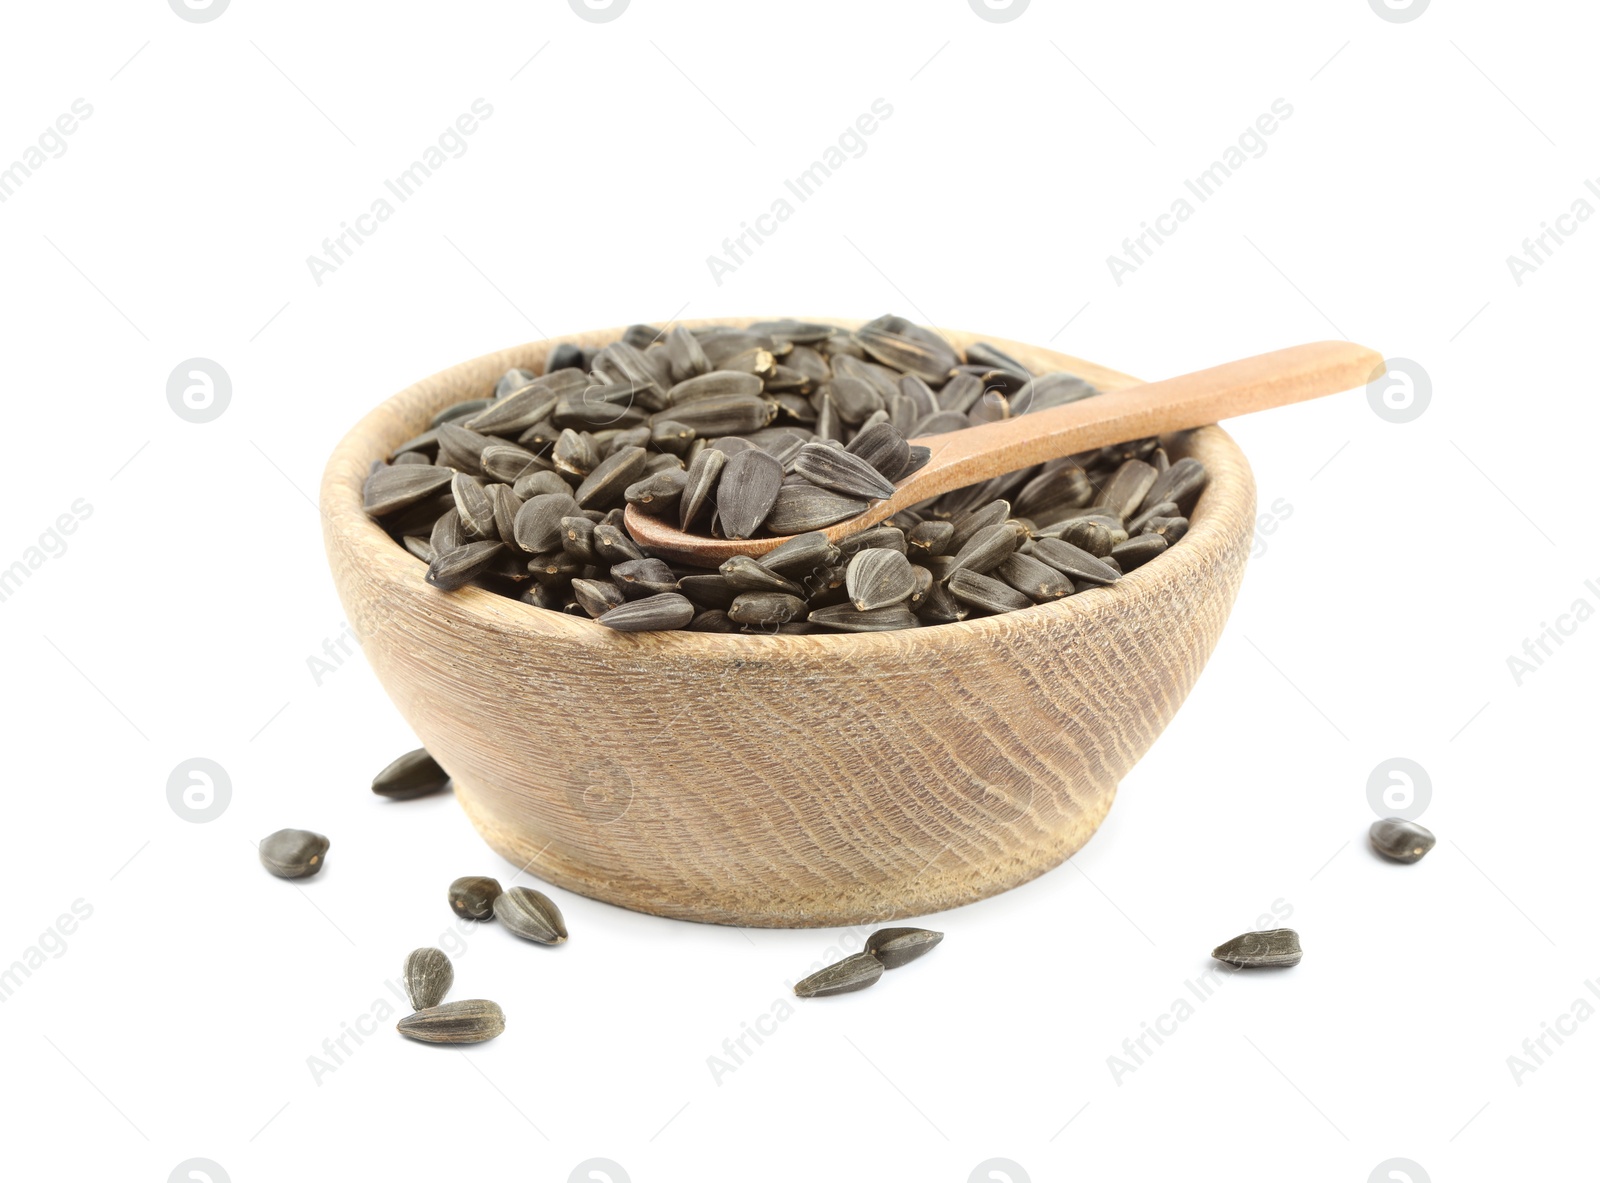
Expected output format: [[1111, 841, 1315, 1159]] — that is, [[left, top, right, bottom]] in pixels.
[[626, 341, 1384, 567]]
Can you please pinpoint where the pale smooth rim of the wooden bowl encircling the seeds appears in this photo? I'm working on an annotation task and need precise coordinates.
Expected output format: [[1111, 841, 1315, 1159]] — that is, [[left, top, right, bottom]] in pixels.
[[318, 317, 1254, 663]]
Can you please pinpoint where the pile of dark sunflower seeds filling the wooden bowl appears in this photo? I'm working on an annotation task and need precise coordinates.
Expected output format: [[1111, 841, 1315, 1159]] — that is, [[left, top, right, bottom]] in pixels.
[[363, 315, 1206, 634]]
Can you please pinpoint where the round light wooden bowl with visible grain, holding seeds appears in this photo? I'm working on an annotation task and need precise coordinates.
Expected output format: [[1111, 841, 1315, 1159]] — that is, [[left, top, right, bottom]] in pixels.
[[322, 321, 1254, 927]]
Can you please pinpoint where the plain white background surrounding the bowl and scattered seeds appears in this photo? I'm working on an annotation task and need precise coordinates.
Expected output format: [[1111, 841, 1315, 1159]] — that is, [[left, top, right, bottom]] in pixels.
[[0, 0, 1600, 1183]]
